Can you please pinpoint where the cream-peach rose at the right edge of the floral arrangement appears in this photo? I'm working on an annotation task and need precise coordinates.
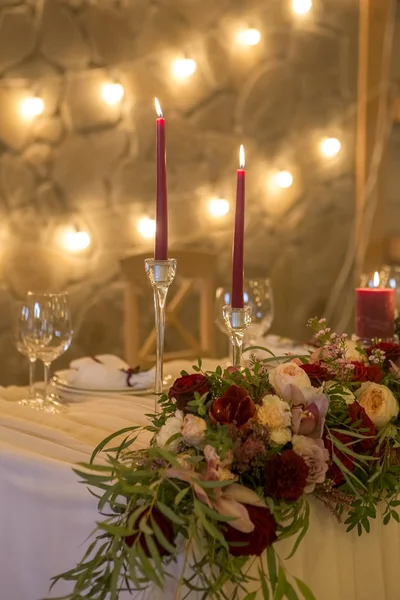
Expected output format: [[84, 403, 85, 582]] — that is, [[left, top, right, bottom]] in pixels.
[[356, 381, 399, 429]]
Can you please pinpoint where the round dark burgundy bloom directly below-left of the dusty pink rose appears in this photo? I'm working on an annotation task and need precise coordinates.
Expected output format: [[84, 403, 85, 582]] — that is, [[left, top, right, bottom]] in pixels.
[[264, 450, 308, 502]]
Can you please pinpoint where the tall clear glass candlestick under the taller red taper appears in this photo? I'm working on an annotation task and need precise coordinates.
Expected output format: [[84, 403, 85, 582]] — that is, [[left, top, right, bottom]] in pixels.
[[144, 258, 176, 413]]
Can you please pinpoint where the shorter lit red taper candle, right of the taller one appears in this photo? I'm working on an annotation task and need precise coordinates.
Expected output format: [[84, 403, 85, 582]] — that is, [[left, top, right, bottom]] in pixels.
[[231, 146, 246, 308]]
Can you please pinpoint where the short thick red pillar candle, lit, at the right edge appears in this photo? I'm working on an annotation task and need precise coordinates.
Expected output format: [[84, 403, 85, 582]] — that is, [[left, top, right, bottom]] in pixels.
[[356, 273, 395, 339]]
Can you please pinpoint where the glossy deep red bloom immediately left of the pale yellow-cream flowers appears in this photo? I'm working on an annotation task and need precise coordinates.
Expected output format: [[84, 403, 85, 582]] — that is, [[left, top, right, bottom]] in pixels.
[[209, 385, 256, 429]]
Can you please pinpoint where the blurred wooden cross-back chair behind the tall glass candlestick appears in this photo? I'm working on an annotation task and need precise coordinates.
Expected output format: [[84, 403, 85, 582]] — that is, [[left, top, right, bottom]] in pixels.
[[120, 250, 217, 367]]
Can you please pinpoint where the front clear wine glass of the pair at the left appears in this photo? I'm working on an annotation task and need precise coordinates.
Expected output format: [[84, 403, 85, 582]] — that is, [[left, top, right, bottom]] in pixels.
[[21, 292, 73, 413]]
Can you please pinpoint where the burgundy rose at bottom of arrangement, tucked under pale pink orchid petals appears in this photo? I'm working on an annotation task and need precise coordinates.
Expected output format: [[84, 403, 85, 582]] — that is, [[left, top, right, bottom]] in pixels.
[[223, 504, 277, 556]]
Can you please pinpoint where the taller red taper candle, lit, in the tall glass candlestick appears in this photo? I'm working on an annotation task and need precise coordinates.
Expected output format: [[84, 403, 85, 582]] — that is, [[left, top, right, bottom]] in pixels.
[[154, 98, 168, 260]]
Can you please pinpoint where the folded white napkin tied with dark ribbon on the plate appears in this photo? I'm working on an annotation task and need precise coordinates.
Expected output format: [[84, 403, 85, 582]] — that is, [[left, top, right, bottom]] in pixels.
[[56, 354, 154, 390]]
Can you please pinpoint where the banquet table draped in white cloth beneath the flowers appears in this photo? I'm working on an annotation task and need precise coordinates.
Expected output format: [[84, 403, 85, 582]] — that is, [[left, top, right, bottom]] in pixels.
[[0, 352, 400, 600]]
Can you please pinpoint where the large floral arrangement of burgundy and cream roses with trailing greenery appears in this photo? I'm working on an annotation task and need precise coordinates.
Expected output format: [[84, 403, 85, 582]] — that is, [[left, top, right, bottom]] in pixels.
[[48, 319, 400, 600]]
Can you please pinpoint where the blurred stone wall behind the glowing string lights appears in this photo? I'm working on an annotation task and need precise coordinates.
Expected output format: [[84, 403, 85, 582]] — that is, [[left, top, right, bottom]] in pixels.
[[0, 0, 358, 384]]
